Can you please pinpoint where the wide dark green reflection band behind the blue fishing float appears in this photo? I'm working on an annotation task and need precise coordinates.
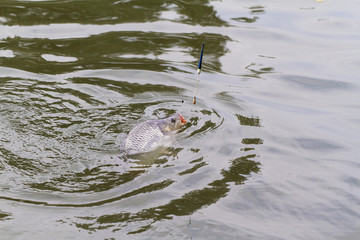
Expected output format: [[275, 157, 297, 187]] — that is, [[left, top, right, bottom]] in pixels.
[[2, 31, 230, 74]]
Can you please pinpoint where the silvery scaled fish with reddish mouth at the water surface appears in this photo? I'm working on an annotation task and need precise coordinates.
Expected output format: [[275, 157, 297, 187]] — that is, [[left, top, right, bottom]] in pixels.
[[123, 113, 186, 154]]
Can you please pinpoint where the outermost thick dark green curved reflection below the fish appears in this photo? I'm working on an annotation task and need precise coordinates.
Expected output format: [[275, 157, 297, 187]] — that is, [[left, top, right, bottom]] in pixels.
[[75, 154, 260, 234]]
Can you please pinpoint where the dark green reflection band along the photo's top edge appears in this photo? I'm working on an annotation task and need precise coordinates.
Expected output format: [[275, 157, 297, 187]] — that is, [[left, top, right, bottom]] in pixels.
[[0, 0, 227, 26]]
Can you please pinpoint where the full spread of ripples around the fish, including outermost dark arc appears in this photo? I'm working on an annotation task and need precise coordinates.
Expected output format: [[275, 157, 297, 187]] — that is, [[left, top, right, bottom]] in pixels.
[[0, 67, 262, 238]]
